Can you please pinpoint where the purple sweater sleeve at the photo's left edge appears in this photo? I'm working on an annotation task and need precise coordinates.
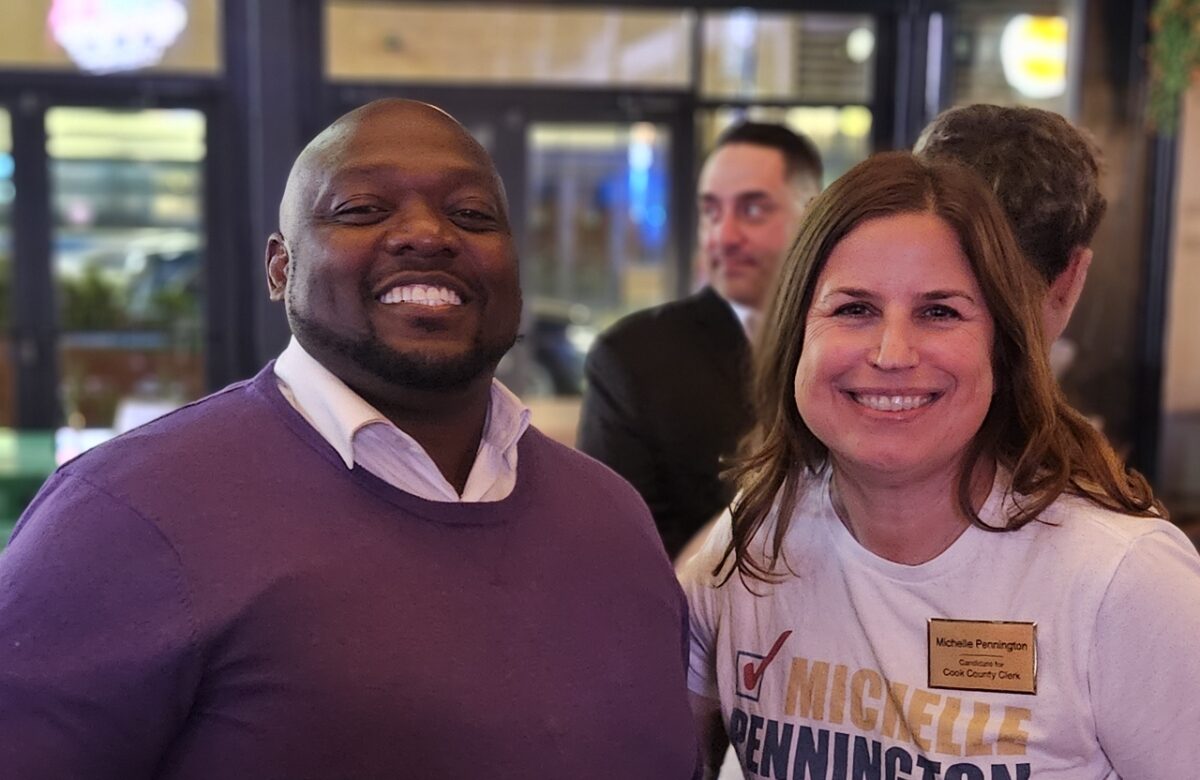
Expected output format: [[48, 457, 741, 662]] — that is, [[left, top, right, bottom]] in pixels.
[[0, 473, 199, 780]]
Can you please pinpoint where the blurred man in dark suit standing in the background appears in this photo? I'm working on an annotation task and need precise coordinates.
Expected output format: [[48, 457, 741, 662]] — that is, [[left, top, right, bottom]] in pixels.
[[578, 122, 822, 558]]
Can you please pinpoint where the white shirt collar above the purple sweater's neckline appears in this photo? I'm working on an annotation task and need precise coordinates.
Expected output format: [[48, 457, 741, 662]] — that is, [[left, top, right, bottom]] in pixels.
[[275, 336, 530, 468]]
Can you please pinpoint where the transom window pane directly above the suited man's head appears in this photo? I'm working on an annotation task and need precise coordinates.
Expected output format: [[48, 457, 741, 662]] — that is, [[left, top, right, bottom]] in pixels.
[[701, 8, 875, 103]]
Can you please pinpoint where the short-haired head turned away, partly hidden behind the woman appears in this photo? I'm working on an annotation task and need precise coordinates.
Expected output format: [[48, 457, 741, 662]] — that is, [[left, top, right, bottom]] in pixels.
[[914, 104, 1106, 343]]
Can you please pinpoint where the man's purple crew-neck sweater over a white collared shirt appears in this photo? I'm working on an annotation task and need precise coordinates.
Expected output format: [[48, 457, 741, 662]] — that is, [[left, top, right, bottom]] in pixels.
[[0, 366, 696, 780]]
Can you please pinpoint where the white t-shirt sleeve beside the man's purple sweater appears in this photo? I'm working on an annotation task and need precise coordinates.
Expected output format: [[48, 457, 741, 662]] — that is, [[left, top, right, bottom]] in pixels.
[[679, 511, 737, 698]]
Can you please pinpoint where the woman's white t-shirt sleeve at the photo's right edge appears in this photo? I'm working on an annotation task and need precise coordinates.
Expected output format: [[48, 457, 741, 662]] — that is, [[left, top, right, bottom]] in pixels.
[[1088, 521, 1200, 780]]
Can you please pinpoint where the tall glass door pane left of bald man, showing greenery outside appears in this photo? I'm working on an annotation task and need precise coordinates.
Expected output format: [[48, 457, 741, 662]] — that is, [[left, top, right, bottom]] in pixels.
[[47, 108, 204, 431]]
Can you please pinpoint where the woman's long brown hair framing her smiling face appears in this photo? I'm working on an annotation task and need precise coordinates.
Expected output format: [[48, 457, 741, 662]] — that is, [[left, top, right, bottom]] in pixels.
[[713, 152, 1166, 582]]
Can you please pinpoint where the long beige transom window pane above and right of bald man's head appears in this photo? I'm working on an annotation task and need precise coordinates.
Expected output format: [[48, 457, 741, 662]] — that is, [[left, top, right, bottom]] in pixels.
[[325, 0, 692, 86]]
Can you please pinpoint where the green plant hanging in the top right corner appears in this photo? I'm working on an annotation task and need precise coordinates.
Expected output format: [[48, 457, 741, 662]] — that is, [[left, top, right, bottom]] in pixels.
[[1148, 0, 1200, 136]]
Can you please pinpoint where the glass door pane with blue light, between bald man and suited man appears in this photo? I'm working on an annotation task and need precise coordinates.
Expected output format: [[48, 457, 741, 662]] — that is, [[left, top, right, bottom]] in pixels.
[[523, 122, 677, 395]]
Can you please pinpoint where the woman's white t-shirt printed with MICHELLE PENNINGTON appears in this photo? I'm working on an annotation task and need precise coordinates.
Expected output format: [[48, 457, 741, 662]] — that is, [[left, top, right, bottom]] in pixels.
[[682, 475, 1200, 780]]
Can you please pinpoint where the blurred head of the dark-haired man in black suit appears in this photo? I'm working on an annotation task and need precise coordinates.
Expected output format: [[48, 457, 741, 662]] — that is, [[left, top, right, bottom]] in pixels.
[[696, 122, 822, 310]]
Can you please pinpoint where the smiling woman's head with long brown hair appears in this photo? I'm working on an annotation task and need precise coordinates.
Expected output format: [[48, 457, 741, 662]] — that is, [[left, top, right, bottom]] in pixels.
[[718, 152, 1157, 578]]
